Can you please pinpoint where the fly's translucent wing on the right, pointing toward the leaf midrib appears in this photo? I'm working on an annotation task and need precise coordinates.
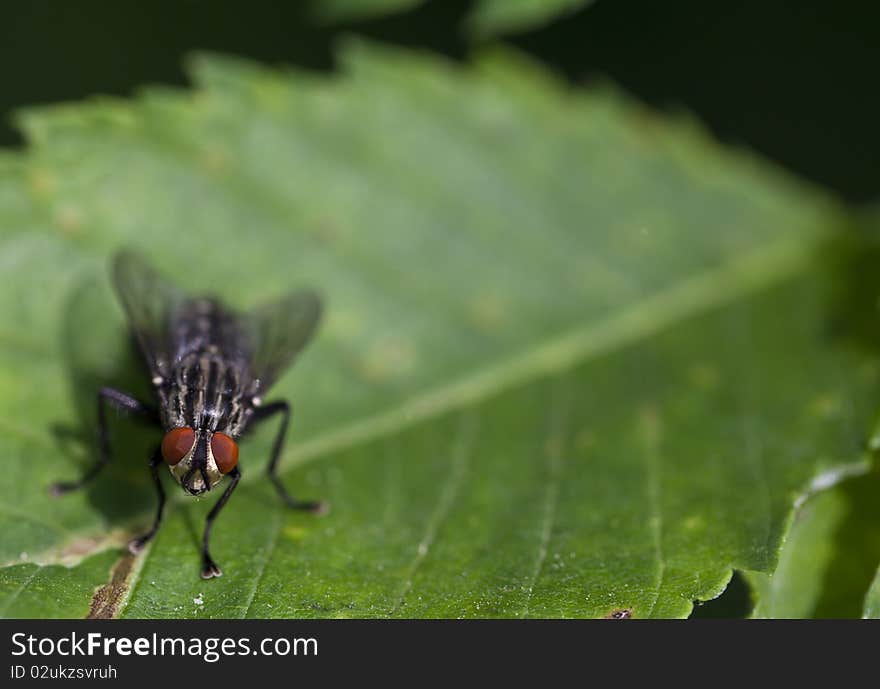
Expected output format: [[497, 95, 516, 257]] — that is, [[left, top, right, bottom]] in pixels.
[[240, 289, 322, 394]]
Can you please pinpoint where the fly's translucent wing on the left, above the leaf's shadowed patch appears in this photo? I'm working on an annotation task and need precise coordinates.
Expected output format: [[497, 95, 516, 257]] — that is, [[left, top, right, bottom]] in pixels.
[[112, 250, 186, 378]]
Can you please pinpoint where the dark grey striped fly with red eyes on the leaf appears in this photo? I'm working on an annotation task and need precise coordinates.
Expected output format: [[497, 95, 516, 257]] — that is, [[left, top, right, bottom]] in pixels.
[[52, 251, 325, 579]]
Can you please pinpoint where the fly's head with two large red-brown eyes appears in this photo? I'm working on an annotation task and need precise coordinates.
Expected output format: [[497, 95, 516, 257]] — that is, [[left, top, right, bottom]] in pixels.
[[162, 426, 238, 495]]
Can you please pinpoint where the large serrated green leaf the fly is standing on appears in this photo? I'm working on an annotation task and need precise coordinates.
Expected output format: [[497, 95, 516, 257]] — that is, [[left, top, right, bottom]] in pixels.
[[0, 40, 878, 617]]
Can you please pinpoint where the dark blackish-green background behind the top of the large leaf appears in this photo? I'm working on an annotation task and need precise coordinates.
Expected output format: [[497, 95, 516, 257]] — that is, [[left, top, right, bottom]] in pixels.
[[0, 0, 880, 202]]
